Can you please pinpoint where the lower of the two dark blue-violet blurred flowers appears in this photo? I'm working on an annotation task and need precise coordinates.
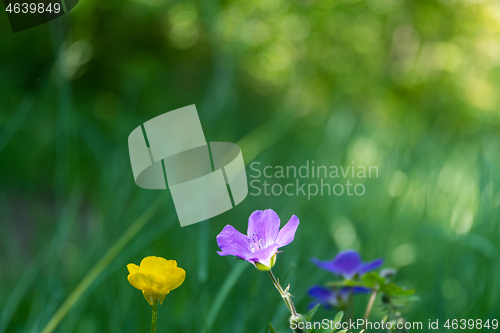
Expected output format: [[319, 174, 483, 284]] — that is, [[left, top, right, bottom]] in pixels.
[[308, 286, 370, 310]]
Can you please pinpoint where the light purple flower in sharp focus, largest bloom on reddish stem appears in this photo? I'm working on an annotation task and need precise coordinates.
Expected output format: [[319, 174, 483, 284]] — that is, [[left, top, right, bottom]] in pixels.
[[217, 209, 299, 271]]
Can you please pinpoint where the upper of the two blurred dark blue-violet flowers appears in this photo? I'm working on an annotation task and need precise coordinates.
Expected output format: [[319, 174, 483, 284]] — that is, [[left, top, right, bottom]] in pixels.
[[312, 250, 384, 280]]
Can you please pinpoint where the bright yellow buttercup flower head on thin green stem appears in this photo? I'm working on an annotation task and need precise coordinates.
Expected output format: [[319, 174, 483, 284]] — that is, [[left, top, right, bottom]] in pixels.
[[127, 257, 186, 305]]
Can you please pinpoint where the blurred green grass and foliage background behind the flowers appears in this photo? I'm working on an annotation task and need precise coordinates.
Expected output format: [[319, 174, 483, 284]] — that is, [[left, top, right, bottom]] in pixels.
[[0, 0, 500, 333]]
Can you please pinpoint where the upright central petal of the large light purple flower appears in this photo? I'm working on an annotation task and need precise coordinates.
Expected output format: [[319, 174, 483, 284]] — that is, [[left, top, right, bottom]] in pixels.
[[247, 209, 280, 248]]
